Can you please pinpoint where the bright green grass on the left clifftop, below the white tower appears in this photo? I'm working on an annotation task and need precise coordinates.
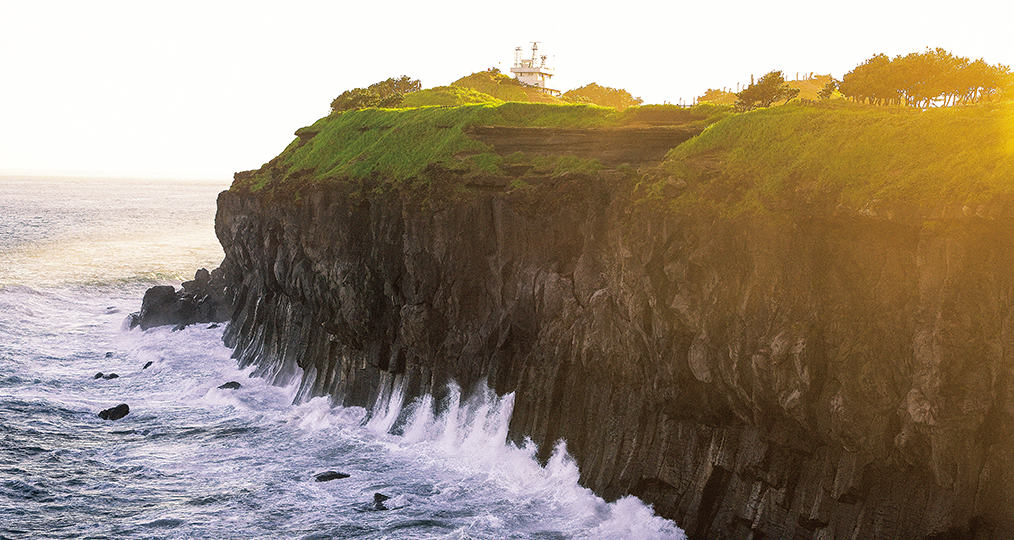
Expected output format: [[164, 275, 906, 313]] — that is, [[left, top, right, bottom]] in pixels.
[[232, 99, 721, 194]]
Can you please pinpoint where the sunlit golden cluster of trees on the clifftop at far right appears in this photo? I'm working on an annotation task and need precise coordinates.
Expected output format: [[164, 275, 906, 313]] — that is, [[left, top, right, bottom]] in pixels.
[[826, 48, 1014, 108]]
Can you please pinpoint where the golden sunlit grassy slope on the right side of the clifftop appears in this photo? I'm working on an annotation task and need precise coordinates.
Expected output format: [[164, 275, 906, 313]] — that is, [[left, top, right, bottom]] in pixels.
[[647, 102, 1014, 214]]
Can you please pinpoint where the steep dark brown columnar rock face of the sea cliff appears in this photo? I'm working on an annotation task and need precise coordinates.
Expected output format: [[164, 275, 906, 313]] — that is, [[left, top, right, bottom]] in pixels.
[[216, 170, 1014, 539]]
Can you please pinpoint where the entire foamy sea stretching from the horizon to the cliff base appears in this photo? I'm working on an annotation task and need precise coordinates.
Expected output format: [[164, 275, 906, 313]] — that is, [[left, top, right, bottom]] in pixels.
[[0, 177, 684, 539]]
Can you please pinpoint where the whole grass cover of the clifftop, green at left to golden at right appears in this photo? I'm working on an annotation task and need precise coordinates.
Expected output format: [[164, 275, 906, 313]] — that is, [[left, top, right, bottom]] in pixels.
[[232, 97, 1014, 215]]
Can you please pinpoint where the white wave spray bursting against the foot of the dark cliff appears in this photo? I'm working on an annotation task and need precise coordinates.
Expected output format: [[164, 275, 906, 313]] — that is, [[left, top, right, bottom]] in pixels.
[[356, 376, 685, 539]]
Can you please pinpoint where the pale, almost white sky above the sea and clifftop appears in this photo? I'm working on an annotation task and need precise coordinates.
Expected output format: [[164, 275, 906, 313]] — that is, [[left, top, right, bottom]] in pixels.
[[0, 0, 1014, 181]]
